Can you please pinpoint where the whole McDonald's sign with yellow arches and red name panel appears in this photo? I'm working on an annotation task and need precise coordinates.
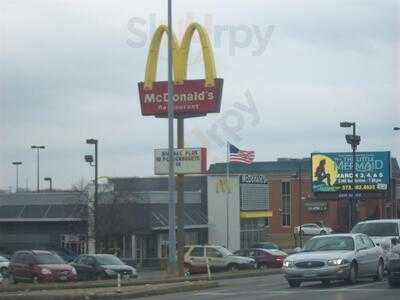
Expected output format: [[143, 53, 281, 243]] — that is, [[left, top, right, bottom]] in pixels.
[[138, 23, 223, 117]]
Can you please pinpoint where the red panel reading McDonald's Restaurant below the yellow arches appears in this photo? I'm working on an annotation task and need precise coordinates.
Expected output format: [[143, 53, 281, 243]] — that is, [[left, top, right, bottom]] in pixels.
[[138, 78, 223, 117]]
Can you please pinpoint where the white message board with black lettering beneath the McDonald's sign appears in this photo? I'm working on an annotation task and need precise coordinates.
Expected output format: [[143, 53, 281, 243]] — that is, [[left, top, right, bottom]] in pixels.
[[154, 148, 207, 175]]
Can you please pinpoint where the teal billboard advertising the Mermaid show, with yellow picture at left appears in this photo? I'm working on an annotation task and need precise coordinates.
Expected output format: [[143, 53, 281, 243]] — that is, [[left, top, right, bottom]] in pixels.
[[311, 152, 390, 193]]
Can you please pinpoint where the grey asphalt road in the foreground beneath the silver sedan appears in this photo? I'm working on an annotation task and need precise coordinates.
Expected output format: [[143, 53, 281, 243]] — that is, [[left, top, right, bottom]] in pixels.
[[130, 274, 400, 300]]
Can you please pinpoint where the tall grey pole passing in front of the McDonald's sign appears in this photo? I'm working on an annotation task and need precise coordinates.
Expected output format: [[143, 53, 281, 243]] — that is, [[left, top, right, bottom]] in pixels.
[[168, 0, 176, 274]]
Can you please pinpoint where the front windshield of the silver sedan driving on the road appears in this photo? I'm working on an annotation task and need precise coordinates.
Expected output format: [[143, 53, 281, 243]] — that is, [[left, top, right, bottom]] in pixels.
[[303, 236, 354, 252]]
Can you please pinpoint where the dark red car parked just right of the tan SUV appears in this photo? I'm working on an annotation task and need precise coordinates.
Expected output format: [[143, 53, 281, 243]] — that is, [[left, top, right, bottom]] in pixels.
[[234, 248, 287, 269]]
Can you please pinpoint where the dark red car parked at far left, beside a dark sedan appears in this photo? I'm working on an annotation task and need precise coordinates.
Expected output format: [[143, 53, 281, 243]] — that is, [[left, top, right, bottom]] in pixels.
[[9, 250, 77, 283]]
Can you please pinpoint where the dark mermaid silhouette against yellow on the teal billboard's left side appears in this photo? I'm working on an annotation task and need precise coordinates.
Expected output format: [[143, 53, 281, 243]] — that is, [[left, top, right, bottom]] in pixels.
[[312, 154, 338, 192]]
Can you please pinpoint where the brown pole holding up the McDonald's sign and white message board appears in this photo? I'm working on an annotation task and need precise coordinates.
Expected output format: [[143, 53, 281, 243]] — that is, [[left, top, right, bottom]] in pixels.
[[176, 118, 185, 277]]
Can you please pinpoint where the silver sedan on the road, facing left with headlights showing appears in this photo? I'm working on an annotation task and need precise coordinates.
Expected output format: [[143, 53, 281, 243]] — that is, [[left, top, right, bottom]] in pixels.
[[283, 234, 384, 287]]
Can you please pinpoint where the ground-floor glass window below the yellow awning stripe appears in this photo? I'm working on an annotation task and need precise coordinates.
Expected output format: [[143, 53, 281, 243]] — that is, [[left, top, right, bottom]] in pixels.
[[240, 218, 268, 249]]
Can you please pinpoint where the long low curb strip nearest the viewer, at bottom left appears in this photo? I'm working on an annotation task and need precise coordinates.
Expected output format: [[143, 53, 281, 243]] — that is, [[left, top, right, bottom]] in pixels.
[[1, 281, 219, 300]]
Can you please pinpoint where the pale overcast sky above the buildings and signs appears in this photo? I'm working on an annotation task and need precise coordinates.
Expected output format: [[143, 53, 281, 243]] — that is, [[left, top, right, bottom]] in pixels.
[[0, 0, 400, 189]]
